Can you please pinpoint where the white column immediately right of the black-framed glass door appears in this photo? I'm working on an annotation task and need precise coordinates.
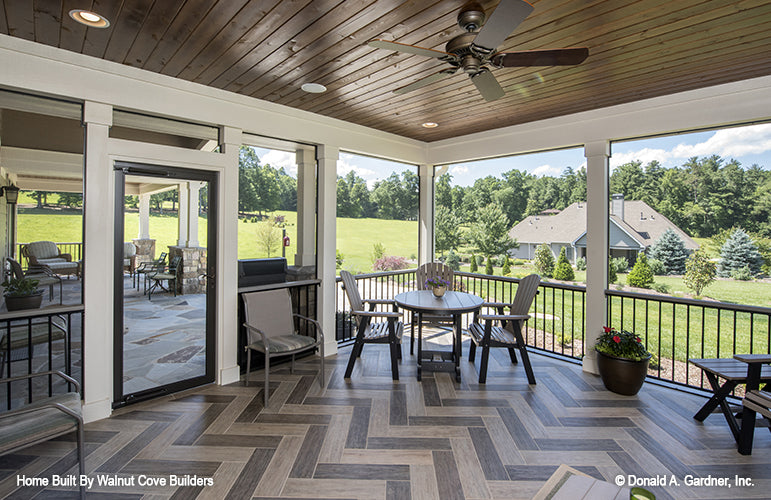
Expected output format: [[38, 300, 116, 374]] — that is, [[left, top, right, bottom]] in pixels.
[[217, 127, 241, 385]]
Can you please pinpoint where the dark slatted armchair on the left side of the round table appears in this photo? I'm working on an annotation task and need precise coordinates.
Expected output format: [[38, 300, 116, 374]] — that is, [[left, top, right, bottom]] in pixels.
[[340, 271, 404, 380]]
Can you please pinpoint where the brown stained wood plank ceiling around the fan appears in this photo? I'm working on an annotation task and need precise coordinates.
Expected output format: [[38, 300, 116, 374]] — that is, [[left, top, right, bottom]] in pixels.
[[0, 0, 771, 141]]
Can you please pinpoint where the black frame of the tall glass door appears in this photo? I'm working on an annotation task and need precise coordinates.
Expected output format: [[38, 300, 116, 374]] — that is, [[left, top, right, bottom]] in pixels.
[[112, 161, 219, 408]]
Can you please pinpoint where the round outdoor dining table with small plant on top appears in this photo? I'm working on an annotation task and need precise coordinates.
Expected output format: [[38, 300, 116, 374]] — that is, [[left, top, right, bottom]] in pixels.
[[394, 290, 483, 382]]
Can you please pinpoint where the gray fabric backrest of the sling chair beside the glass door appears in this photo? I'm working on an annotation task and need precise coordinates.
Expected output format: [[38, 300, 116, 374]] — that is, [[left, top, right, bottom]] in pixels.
[[242, 288, 296, 344]]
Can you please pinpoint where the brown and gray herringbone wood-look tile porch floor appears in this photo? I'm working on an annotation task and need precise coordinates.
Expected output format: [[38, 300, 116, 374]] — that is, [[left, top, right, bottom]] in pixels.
[[0, 338, 771, 499]]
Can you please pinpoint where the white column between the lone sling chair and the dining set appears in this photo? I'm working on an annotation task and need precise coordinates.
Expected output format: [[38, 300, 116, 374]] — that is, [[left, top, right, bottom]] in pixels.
[[316, 145, 340, 356]]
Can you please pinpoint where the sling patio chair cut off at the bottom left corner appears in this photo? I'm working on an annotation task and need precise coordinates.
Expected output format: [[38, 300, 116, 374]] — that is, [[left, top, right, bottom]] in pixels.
[[0, 371, 86, 498]]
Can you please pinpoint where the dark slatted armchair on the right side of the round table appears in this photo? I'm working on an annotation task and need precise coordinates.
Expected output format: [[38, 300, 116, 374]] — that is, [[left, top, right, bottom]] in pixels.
[[468, 274, 541, 384]]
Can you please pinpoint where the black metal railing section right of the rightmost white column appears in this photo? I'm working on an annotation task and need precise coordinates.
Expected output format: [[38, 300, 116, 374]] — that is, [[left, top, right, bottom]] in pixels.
[[605, 290, 771, 389]]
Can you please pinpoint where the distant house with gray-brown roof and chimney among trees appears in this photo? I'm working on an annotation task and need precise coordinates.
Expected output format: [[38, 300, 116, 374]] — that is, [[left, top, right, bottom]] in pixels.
[[509, 194, 699, 264]]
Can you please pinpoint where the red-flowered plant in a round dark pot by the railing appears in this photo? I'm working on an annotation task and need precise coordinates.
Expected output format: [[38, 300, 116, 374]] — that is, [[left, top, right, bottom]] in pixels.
[[594, 326, 651, 396]]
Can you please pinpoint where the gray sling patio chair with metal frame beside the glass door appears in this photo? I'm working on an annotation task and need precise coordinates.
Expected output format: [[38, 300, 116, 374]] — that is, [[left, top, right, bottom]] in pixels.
[[242, 288, 324, 407]]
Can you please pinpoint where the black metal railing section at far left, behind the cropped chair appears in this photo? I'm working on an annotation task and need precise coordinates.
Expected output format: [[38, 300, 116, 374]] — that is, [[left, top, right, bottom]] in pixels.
[[0, 305, 84, 409]]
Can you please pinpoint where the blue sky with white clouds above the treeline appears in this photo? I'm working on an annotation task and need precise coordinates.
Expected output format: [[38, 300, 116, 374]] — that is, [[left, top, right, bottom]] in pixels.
[[257, 124, 771, 188]]
